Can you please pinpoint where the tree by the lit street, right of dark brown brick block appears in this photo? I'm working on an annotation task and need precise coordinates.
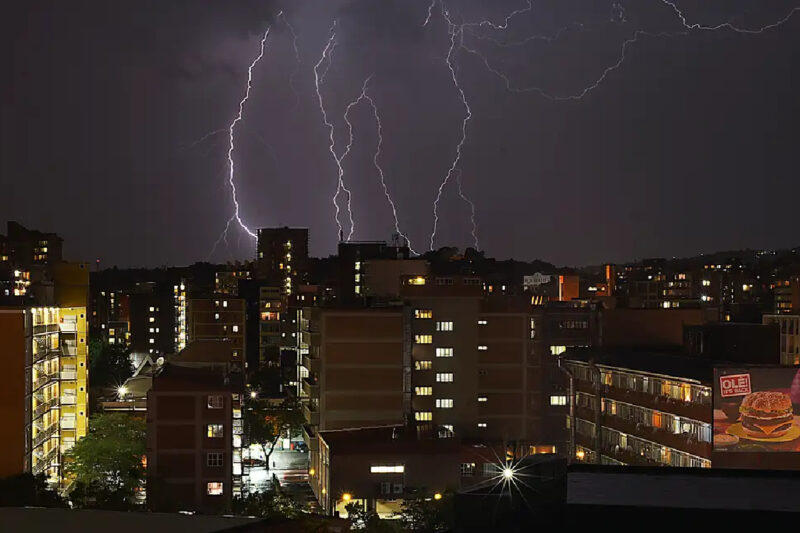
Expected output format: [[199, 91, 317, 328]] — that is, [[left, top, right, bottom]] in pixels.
[[244, 398, 305, 468]]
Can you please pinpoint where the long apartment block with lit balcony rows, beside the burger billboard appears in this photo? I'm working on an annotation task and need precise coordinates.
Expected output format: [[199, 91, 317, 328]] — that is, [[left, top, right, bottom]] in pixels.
[[560, 349, 713, 468]]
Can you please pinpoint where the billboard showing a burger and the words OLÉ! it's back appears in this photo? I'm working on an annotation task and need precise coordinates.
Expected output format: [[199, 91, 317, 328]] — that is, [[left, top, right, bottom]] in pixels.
[[713, 367, 800, 454]]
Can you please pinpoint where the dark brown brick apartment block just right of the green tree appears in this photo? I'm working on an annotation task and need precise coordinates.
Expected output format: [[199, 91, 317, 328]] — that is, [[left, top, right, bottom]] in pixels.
[[147, 364, 244, 513]]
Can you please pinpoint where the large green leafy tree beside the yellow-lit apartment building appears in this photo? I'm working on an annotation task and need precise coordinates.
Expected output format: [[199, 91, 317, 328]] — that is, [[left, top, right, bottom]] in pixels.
[[64, 413, 146, 509]]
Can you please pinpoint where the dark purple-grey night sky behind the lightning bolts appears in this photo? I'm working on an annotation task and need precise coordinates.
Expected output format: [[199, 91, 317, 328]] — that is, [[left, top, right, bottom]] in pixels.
[[0, 0, 800, 266]]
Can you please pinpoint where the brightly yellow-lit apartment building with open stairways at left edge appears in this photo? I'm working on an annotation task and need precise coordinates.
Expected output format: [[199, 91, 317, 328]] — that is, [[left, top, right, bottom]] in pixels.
[[0, 307, 88, 485]]
